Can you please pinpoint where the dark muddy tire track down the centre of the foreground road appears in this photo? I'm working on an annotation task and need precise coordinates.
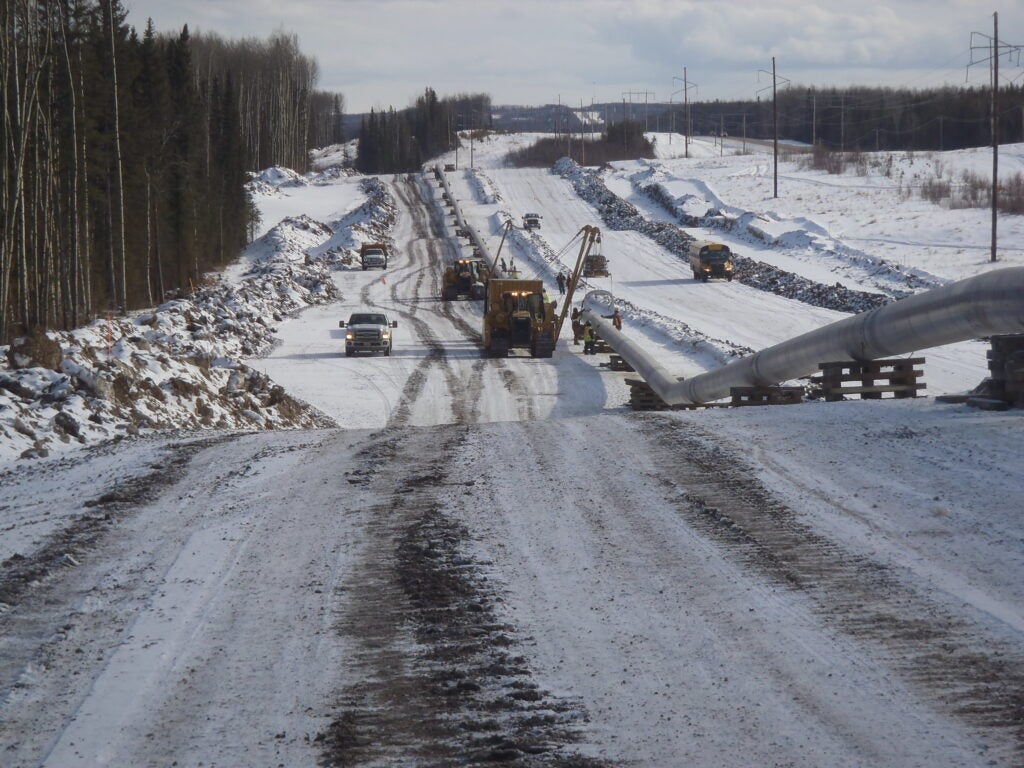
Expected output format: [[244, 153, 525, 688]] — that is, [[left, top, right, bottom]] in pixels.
[[316, 426, 604, 768]]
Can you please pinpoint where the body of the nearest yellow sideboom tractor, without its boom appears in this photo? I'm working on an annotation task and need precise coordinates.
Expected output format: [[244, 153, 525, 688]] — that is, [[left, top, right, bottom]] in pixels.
[[483, 278, 555, 357]]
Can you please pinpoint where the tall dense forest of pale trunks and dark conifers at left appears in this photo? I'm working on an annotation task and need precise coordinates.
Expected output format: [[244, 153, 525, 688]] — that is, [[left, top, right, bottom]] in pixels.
[[0, 0, 343, 343]]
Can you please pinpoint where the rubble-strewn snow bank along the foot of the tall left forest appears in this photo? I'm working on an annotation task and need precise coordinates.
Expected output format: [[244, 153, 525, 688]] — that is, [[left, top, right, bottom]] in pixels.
[[0, 180, 395, 461]]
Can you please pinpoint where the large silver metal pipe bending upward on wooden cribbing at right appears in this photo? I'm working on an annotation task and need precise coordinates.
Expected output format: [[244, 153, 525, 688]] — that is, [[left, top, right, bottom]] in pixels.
[[583, 267, 1024, 406]]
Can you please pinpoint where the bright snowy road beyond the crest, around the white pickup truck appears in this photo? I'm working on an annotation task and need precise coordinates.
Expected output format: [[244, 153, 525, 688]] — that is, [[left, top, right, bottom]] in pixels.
[[251, 177, 628, 434]]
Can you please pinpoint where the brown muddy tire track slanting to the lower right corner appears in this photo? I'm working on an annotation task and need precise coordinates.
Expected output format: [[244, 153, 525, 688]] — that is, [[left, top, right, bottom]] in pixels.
[[642, 417, 1024, 765]]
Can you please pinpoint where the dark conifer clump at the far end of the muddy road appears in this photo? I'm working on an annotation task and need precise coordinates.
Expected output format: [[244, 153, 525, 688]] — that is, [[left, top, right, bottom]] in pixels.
[[355, 88, 490, 173]]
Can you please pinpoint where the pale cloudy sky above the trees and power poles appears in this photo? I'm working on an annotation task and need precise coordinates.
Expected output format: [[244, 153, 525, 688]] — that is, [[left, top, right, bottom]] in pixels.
[[123, 0, 1024, 113]]
